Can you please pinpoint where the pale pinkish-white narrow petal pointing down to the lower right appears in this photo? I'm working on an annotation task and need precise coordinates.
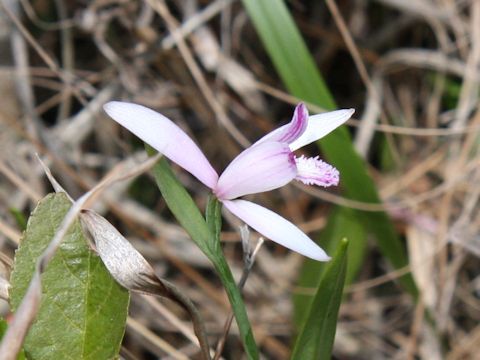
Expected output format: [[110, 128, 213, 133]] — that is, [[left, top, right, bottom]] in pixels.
[[223, 200, 330, 261]]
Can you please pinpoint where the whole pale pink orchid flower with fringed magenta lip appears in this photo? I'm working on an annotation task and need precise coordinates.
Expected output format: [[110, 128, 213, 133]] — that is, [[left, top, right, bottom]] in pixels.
[[104, 101, 354, 261]]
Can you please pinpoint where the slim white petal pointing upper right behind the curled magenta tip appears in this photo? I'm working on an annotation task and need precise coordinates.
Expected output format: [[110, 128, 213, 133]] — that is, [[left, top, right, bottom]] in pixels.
[[290, 109, 355, 151]]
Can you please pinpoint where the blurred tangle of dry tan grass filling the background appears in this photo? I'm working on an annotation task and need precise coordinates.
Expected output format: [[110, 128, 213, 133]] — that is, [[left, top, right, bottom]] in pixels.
[[0, 0, 480, 360]]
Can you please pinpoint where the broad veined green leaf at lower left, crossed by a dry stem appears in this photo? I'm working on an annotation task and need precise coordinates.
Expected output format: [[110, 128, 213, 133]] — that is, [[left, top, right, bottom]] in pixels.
[[10, 193, 129, 360]]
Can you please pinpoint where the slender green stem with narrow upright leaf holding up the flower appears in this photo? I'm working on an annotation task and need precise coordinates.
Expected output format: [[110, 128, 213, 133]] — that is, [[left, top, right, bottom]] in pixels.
[[146, 153, 259, 359]]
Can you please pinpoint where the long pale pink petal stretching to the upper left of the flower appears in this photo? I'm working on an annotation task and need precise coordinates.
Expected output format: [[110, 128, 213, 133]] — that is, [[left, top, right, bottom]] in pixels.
[[103, 101, 218, 189]]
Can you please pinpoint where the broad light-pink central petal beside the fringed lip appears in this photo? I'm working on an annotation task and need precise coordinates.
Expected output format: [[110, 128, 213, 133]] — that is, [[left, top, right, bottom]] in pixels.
[[213, 142, 297, 200]]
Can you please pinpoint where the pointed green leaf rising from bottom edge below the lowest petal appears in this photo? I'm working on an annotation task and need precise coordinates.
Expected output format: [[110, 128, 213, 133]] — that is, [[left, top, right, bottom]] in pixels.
[[291, 239, 348, 360]]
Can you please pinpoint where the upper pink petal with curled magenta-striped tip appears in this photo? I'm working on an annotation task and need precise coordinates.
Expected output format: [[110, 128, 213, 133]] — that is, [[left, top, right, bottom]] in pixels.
[[254, 103, 308, 146]]
